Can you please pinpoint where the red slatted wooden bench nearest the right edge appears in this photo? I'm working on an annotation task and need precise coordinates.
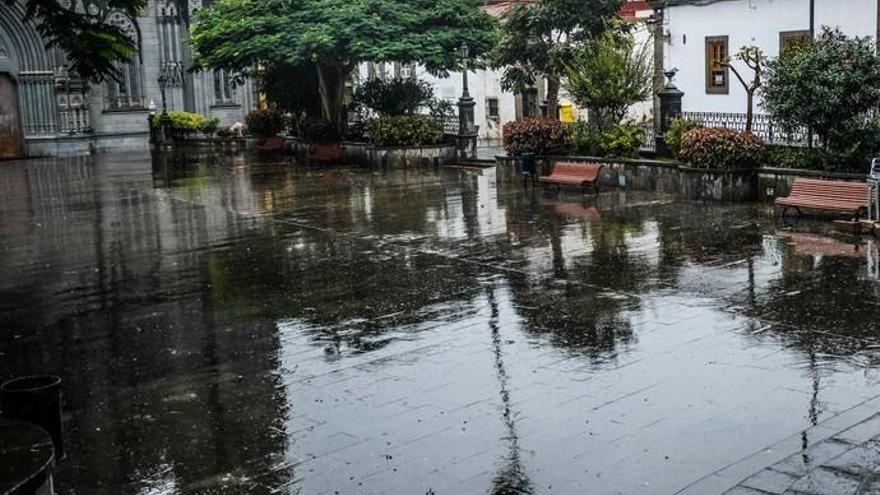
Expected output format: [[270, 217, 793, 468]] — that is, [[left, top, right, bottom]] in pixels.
[[776, 177, 869, 218]]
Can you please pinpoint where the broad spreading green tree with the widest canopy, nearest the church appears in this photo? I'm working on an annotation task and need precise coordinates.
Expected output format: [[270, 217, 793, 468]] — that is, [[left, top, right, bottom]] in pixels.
[[192, 0, 494, 131]]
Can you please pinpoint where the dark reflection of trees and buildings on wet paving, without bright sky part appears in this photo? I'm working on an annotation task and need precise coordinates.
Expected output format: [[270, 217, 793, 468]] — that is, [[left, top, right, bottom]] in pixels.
[[0, 156, 880, 494]]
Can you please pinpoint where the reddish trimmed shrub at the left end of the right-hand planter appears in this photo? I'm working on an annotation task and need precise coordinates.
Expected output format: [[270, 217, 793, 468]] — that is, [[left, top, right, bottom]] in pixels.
[[503, 117, 571, 156]]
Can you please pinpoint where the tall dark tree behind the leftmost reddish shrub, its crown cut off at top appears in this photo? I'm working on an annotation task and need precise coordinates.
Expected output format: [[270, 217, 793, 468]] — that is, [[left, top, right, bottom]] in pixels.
[[490, 0, 622, 119]]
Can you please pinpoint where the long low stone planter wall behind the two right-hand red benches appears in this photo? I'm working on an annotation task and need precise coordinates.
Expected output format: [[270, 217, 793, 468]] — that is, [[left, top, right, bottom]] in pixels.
[[497, 156, 865, 202]]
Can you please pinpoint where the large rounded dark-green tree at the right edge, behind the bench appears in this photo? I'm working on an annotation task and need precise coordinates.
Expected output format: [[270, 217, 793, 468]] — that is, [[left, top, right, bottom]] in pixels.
[[762, 27, 880, 160]]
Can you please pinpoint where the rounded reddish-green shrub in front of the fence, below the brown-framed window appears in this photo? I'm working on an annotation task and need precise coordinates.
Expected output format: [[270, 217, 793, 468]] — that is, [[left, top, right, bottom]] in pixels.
[[679, 127, 765, 169]]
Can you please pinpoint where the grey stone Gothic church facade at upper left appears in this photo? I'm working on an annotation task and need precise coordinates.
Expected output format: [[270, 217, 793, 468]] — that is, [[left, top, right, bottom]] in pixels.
[[0, 0, 257, 158]]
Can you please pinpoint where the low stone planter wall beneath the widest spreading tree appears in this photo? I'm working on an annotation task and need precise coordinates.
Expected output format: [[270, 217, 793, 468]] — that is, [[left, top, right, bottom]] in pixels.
[[291, 140, 457, 168]]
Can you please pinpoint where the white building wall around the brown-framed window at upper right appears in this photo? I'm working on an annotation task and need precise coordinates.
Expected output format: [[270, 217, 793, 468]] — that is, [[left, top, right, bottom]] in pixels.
[[664, 0, 877, 113]]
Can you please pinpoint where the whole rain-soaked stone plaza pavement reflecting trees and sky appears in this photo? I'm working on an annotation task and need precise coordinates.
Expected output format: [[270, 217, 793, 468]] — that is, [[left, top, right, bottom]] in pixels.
[[0, 155, 880, 495]]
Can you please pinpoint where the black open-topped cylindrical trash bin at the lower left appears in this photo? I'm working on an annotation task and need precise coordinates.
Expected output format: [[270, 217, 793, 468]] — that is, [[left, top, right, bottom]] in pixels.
[[0, 375, 64, 461]]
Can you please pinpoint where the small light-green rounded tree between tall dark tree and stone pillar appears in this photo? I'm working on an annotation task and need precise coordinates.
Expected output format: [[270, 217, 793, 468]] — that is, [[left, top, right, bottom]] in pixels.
[[564, 30, 654, 131]]
